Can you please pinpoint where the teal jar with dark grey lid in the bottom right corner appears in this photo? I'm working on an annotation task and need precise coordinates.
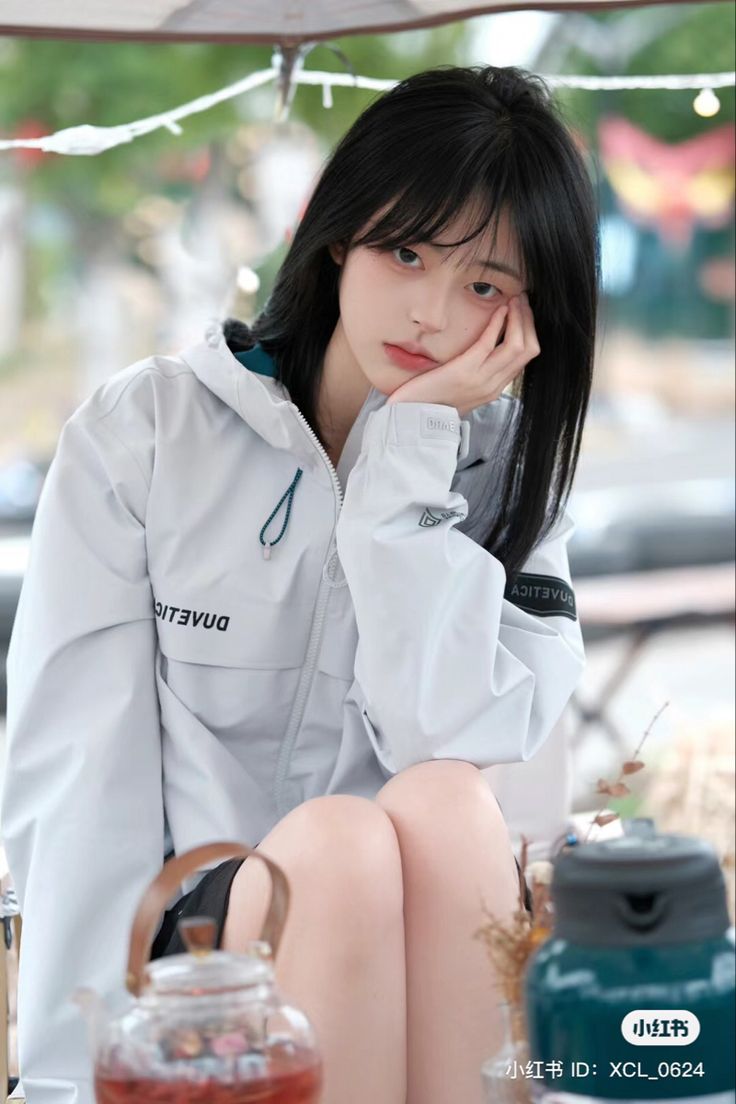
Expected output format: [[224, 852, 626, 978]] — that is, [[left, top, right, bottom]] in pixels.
[[525, 830, 736, 1104]]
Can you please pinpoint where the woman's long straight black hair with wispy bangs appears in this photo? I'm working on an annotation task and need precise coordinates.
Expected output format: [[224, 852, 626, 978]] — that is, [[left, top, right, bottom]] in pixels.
[[224, 65, 599, 577]]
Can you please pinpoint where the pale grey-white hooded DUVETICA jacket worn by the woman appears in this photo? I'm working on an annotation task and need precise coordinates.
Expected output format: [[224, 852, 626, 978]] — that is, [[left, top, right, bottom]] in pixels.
[[2, 325, 584, 1104]]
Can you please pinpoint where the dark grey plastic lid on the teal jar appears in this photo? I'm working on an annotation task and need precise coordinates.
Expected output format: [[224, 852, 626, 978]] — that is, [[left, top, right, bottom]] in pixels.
[[552, 831, 729, 946]]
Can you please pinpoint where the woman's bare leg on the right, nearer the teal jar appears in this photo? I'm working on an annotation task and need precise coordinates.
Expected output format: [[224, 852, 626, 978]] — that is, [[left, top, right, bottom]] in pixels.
[[376, 760, 519, 1104]]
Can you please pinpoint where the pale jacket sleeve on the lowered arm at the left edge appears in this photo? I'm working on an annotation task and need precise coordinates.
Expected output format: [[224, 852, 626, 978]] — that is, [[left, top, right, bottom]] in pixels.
[[2, 407, 163, 1104]]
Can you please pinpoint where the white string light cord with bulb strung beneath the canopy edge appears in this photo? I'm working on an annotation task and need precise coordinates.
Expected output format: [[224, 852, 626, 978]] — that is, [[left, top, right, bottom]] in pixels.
[[0, 62, 736, 157]]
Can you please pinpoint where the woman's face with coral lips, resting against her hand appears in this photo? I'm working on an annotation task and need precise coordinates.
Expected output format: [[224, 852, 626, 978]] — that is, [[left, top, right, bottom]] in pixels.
[[332, 207, 526, 394]]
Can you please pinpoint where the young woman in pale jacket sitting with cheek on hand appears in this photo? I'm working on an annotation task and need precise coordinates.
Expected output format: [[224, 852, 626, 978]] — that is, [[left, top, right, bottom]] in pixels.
[[3, 67, 597, 1104]]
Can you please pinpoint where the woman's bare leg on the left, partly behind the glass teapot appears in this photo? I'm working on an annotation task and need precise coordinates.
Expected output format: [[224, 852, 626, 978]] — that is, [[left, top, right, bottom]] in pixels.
[[223, 795, 406, 1104]]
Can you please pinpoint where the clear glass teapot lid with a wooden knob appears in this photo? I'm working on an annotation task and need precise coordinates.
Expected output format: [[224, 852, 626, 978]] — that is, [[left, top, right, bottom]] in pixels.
[[146, 916, 274, 997]]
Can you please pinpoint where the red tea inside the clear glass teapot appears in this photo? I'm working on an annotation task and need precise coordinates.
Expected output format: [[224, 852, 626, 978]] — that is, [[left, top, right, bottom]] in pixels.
[[95, 1065, 322, 1104]]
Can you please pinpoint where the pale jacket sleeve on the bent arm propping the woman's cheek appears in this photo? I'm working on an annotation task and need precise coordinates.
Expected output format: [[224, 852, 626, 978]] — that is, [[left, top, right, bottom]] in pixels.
[[337, 403, 584, 773]]
